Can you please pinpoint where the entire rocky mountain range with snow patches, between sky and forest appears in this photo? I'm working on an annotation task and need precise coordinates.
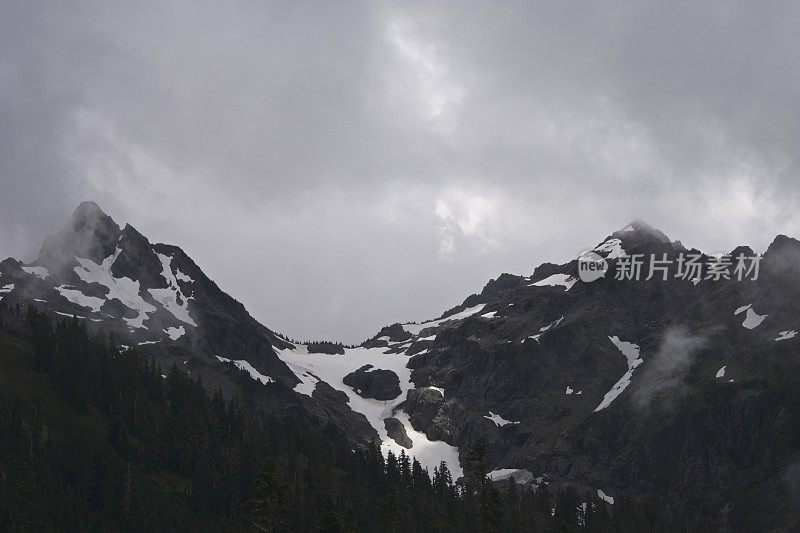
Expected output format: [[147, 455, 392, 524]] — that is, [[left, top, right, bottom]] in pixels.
[[0, 202, 800, 530]]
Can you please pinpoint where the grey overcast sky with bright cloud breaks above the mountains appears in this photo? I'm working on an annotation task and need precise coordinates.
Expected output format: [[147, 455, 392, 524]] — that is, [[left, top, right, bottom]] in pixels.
[[0, 0, 800, 342]]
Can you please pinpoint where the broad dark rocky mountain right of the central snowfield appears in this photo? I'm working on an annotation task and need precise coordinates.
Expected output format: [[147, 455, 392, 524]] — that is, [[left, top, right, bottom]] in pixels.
[[390, 223, 800, 528]]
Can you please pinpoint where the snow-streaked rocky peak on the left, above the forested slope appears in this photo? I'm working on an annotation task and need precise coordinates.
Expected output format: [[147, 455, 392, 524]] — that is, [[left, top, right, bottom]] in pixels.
[[0, 202, 299, 412]]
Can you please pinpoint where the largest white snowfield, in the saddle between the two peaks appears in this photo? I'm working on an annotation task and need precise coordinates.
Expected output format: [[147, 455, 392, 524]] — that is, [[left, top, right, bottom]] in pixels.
[[275, 342, 462, 479]]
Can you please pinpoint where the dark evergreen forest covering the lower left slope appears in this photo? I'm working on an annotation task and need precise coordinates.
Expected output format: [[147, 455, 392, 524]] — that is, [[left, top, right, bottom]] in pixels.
[[0, 302, 663, 531]]
